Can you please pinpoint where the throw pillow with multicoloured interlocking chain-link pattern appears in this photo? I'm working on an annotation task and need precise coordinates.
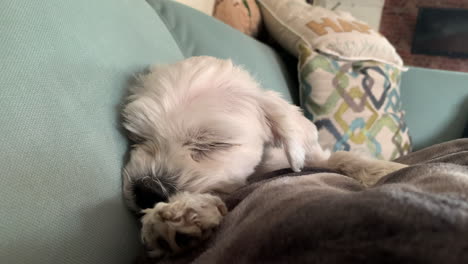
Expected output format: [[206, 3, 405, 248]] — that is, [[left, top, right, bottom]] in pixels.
[[299, 45, 411, 160]]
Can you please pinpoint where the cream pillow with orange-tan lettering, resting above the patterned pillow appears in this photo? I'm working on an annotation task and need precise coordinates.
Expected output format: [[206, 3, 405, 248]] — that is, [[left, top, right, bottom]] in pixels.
[[258, 0, 403, 69]]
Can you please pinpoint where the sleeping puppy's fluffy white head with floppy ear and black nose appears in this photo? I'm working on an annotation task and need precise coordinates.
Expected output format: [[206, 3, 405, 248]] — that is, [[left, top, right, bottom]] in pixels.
[[123, 57, 326, 209]]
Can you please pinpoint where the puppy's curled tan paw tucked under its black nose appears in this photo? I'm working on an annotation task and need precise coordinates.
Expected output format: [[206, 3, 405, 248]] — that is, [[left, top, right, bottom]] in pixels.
[[141, 192, 227, 257]]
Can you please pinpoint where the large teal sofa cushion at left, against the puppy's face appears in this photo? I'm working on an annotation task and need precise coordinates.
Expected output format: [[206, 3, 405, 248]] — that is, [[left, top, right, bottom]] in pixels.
[[0, 0, 183, 264]]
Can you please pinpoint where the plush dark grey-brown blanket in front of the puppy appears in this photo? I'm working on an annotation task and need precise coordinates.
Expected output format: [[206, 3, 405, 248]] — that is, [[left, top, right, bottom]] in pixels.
[[141, 139, 468, 264]]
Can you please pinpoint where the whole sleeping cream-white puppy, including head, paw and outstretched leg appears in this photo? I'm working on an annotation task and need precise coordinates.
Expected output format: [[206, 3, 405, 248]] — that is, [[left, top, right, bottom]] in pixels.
[[123, 56, 405, 257]]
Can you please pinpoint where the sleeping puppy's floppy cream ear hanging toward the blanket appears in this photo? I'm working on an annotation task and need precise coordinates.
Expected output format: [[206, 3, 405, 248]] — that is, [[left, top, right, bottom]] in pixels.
[[258, 91, 325, 172]]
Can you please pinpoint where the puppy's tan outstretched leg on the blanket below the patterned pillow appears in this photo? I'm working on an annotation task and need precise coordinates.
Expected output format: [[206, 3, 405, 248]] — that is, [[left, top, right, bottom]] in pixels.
[[327, 151, 408, 186]]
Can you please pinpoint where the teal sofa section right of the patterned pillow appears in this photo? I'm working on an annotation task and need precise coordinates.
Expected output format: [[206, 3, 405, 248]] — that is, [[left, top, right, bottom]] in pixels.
[[401, 67, 468, 150]]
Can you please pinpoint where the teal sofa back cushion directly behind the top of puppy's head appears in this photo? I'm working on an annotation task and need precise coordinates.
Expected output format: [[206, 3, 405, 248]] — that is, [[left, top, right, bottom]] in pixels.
[[148, 0, 297, 102]]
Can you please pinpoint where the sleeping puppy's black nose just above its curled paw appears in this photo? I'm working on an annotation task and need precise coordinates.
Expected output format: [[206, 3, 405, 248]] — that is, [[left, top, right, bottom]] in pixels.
[[133, 177, 175, 209]]
